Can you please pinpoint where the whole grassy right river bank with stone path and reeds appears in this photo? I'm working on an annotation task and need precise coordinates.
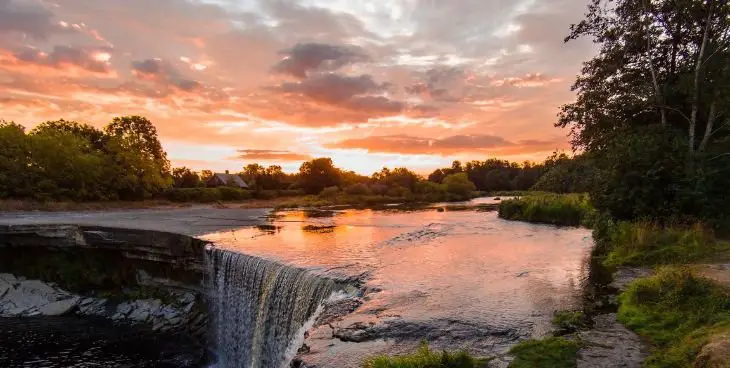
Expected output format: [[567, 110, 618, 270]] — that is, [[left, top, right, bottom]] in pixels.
[[500, 195, 730, 368]]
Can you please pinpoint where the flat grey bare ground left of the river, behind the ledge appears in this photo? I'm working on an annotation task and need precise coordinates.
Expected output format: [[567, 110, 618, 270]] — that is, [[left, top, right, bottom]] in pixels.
[[0, 205, 271, 236]]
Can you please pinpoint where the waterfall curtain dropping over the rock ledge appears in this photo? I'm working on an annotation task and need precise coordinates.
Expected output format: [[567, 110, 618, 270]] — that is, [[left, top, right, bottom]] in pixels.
[[208, 248, 335, 368]]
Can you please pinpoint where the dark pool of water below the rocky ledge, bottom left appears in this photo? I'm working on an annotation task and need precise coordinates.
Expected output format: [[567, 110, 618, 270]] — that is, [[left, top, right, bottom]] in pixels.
[[0, 317, 204, 368]]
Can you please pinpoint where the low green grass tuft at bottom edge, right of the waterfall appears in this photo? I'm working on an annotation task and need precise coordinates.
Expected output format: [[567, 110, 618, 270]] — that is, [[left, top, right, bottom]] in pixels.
[[364, 343, 487, 368]]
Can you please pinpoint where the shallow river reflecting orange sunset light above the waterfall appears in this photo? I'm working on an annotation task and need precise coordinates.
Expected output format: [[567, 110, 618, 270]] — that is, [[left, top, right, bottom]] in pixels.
[[205, 199, 593, 367]]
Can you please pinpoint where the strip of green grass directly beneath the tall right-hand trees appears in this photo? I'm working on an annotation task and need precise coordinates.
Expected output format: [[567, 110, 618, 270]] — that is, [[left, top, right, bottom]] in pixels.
[[597, 222, 730, 266]]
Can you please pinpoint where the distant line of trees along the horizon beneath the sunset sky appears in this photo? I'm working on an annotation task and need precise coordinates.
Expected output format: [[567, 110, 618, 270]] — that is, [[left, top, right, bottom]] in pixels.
[[0, 116, 583, 201]]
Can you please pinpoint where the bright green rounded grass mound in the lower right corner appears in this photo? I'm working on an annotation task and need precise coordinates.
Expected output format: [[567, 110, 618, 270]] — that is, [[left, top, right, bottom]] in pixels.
[[618, 267, 730, 368]]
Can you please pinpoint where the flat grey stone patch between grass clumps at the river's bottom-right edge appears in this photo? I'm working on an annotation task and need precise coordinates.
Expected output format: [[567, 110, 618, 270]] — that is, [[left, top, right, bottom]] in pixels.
[[577, 313, 646, 368]]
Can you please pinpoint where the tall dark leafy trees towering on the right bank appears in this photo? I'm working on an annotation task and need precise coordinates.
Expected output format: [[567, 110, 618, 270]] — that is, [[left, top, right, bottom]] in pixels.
[[546, 0, 730, 224]]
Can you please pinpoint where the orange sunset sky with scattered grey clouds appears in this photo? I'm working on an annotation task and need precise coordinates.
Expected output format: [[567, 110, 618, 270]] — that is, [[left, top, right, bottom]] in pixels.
[[0, 0, 595, 174]]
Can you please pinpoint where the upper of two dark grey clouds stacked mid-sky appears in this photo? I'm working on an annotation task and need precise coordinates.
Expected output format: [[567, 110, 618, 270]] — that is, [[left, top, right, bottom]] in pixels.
[[272, 43, 371, 79]]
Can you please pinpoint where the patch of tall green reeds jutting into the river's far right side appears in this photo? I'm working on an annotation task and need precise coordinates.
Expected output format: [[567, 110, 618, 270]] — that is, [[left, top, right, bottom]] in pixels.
[[499, 192, 596, 226]]
